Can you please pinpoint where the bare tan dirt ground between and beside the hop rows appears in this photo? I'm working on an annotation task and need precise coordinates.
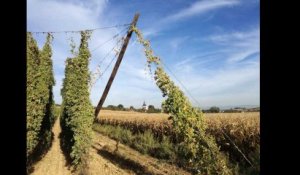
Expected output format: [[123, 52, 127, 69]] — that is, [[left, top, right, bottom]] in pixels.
[[32, 119, 190, 175]]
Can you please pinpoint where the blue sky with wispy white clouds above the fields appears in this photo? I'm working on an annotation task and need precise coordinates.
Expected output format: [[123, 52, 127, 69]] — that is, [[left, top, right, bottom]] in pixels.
[[27, 0, 260, 108]]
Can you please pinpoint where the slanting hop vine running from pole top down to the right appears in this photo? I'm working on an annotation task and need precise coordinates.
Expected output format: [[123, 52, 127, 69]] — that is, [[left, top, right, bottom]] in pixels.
[[131, 27, 232, 175]]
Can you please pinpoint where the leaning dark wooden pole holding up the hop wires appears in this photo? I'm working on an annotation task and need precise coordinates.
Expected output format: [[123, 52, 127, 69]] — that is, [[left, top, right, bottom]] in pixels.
[[95, 13, 140, 119]]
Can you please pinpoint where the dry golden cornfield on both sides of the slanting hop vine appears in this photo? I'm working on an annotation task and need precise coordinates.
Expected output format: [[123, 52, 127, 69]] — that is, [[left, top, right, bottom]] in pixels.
[[98, 110, 260, 174]]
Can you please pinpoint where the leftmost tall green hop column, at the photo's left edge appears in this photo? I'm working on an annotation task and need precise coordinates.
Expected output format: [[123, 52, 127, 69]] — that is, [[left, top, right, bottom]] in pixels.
[[26, 33, 55, 166]]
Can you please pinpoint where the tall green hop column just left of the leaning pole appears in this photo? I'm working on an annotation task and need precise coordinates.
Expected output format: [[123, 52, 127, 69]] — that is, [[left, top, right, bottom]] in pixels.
[[61, 32, 94, 169]]
